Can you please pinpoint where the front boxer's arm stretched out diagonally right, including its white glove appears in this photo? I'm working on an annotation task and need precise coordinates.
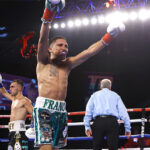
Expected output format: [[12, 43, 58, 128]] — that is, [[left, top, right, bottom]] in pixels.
[[69, 23, 125, 69]]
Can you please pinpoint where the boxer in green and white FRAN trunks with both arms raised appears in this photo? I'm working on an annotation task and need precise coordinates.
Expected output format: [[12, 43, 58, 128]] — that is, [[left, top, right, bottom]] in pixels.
[[33, 0, 124, 150]]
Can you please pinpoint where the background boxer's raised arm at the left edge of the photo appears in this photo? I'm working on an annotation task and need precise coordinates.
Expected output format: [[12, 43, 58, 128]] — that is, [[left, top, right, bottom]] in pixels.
[[0, 74, 14, 100]]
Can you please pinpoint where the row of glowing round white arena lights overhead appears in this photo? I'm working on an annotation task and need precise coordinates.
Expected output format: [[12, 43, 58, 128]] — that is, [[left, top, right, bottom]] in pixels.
[[52, 6, 150, 29]]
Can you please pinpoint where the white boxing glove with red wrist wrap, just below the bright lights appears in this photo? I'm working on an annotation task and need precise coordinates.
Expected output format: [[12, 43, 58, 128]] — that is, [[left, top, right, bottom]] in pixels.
[[102, 22, 125, 45]]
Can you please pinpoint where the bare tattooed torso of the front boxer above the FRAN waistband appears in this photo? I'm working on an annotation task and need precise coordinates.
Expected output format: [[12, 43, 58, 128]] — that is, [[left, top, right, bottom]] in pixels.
[[36, 63, 70, 100]]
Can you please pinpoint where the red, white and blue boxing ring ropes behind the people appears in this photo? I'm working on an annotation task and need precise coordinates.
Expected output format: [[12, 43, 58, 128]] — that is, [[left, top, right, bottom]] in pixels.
[[0, 108, 150, 150]]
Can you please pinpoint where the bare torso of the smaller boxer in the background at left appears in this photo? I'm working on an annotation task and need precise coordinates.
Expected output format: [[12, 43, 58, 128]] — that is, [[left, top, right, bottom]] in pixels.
[[10, 97, 27, 121]]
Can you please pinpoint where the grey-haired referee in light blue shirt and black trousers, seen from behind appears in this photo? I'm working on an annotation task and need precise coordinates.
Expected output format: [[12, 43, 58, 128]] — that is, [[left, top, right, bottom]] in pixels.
[[84, 79, 131, 150]]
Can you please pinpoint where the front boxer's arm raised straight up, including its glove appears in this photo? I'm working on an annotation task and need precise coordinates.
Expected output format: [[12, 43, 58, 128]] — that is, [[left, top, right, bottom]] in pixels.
[[37, 0, 65, 63]]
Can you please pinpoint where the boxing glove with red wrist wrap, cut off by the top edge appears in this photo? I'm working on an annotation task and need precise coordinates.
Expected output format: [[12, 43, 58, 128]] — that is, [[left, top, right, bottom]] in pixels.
[[41, 0, 65, 23]]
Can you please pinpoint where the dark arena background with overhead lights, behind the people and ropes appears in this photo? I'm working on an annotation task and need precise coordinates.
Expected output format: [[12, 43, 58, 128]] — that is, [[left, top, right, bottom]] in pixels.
[[0, 0, 150, 150]]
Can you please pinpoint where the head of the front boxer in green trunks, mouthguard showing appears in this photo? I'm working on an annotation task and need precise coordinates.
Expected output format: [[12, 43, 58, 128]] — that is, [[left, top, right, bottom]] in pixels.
[[49, 39, 68, 60]]
